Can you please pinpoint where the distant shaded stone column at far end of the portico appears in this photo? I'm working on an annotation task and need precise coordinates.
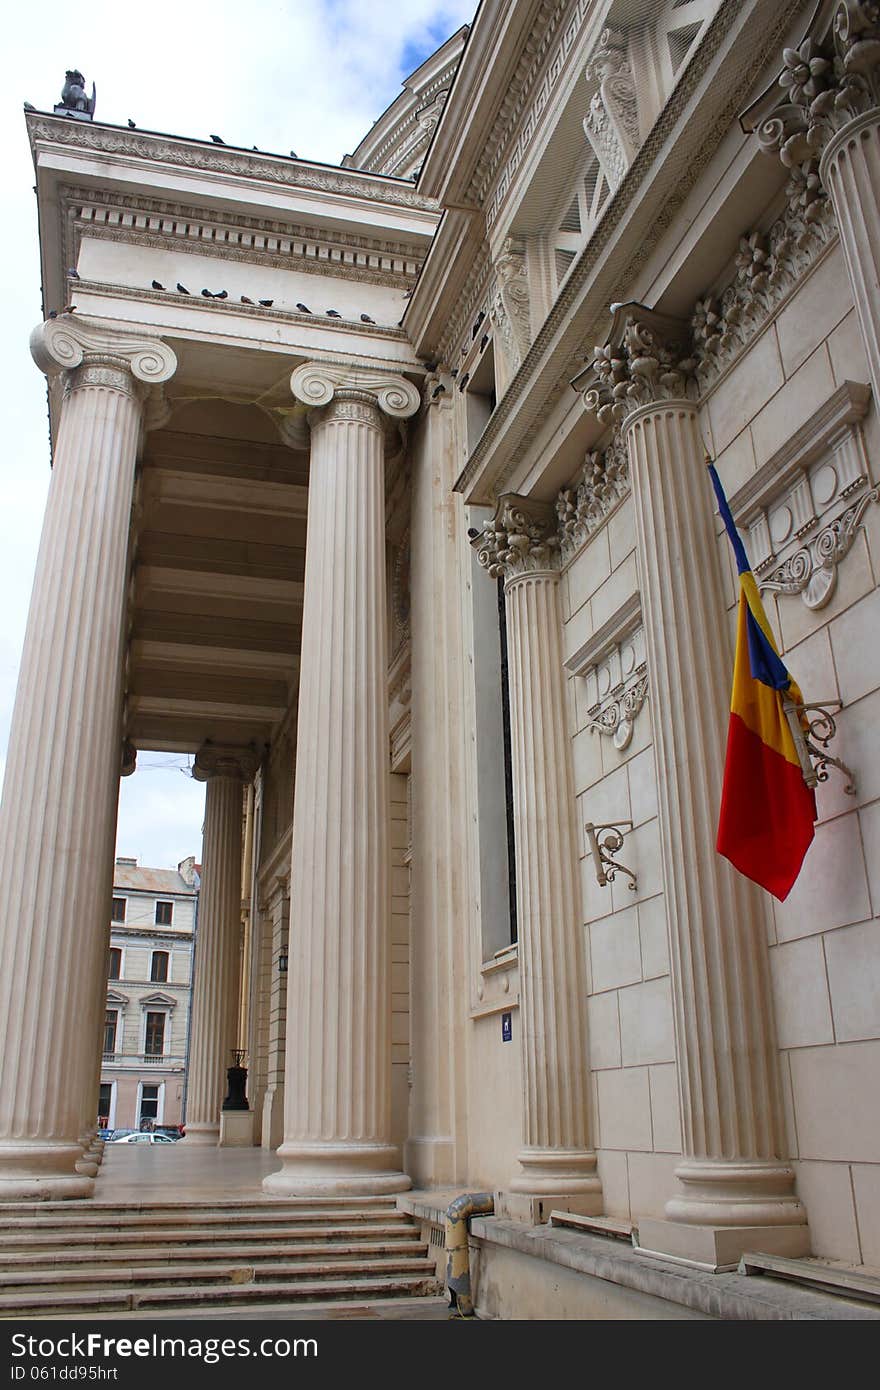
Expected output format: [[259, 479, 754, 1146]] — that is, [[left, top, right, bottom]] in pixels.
[[185, 744, 259, 1144]]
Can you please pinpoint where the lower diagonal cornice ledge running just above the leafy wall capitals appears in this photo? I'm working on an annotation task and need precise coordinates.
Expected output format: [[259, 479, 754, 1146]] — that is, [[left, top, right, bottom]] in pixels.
[[455, 0, 799, 502]]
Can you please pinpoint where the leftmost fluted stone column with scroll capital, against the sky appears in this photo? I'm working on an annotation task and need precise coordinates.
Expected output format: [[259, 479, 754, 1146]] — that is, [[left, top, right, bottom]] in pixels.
[[0, 320, 177, 1200]]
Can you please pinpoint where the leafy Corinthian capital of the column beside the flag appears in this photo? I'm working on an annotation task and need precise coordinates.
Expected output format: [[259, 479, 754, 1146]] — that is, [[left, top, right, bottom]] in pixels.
[[571, 303, 699, 425]]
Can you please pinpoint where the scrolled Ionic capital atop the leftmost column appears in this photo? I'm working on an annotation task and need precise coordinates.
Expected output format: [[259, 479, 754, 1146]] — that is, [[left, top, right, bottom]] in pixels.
[[31, 316, 177, 395]]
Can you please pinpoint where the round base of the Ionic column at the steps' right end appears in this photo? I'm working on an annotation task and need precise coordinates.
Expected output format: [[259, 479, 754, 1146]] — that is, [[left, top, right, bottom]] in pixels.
[[263, 1143, 412, 1197]]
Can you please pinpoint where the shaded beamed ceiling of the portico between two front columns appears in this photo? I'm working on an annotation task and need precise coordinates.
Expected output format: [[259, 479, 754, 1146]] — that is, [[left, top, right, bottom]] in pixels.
[[127, 400, 309, 752]]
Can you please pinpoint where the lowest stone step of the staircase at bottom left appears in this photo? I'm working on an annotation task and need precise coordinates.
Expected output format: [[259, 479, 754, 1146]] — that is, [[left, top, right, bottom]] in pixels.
[[0, 1275, 439, 1318]]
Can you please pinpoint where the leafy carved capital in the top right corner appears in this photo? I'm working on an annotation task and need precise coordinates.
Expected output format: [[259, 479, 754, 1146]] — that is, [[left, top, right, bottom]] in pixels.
[[741, 0, 880, 170]]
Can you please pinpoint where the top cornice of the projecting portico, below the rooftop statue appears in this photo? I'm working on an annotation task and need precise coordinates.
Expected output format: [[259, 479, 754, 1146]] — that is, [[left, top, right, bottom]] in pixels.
[[26, 111, 438, 213]]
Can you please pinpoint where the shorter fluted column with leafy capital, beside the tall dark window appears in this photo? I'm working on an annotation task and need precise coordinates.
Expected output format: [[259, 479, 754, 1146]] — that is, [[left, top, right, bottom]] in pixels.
[[473, 495, 602, 1222]]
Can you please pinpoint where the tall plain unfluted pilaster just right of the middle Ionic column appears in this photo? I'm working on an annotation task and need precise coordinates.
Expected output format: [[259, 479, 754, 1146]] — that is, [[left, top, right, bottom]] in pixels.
[[405, 374, 470, 1187]]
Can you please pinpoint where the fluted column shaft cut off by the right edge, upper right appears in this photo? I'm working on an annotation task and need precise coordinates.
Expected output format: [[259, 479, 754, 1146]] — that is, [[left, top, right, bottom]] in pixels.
[[820, 107, 880, 402]]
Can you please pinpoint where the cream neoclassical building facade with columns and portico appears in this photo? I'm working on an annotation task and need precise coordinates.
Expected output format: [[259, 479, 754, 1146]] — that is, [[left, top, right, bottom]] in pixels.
[[0, 0, 880, 1315]]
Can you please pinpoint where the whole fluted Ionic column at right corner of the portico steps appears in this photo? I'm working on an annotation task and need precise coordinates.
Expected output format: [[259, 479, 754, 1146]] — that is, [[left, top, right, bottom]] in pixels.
[[263, 363, 418, 1197]]
